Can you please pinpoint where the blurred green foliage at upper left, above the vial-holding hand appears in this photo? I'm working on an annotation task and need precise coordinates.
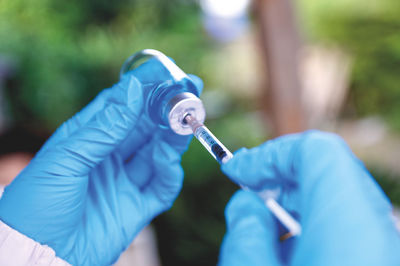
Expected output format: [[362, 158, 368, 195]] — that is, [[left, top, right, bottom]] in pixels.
[[0, 0, 209, 130]]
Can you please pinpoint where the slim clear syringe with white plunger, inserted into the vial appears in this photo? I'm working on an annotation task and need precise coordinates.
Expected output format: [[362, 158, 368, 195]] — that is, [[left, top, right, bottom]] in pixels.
[[183, 114, 301, 241]]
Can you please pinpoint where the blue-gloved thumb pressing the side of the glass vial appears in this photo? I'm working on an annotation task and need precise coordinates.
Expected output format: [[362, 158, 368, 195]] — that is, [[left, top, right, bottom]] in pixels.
[[39, 77, 143, 176]]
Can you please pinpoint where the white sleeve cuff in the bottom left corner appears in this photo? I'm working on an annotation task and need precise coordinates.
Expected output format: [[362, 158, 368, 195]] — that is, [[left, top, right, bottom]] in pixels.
[[0, 221, 70, 266]]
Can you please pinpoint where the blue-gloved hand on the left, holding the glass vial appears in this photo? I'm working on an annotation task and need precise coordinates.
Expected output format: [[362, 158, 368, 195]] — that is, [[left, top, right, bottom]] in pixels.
[[0, 60, 202, 265]]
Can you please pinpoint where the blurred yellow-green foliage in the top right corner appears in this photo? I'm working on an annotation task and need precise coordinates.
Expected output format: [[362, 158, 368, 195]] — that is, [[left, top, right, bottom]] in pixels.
[[300, 0, 400, 130]]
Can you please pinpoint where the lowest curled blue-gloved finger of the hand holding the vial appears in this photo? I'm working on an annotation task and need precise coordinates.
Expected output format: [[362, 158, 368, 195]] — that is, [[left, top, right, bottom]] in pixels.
[[143, 140, 183, 219]]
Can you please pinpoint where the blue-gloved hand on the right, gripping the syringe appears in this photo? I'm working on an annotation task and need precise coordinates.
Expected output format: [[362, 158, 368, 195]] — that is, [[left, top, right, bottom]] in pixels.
[[219, 131, 400, 266]]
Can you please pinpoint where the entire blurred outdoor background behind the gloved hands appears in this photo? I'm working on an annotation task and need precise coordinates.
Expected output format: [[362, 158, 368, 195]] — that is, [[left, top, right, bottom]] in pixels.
[[0, 0, 400, 265]]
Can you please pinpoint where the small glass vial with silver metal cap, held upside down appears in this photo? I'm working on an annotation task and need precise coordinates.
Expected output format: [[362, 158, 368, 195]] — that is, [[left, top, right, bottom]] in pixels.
[[120, 49, 205, 135]]
